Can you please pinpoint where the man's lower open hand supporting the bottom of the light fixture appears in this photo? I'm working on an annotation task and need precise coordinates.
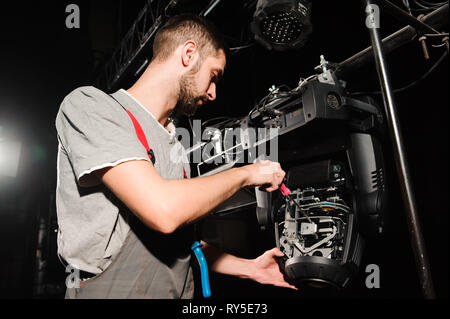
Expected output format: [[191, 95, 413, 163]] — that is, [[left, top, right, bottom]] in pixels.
[[250, 248, 298, 290]]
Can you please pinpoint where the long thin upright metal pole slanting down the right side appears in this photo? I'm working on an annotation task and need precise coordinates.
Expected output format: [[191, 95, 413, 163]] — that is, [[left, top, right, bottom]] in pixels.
[[364, 0, 435, 299]]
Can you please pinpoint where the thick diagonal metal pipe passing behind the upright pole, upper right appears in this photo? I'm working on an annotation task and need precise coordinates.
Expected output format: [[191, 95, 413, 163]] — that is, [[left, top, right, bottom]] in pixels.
[[335, 4, 449, 79]]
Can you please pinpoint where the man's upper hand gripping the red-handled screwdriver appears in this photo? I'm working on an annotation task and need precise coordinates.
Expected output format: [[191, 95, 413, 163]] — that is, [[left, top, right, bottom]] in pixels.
[[241, 161, 286, 192]]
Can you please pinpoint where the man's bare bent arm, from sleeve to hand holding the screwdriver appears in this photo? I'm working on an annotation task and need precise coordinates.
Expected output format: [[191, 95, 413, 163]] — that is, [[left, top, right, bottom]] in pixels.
[[93, 161, 285, 234]]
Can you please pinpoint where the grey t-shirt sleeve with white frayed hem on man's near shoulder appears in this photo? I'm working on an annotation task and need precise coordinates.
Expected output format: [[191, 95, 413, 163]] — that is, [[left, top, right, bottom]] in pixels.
[[55, 87, 150, 187]]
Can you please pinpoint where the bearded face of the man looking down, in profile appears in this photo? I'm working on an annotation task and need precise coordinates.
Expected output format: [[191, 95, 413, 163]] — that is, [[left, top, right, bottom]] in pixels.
[[175, 50, 226, 116]]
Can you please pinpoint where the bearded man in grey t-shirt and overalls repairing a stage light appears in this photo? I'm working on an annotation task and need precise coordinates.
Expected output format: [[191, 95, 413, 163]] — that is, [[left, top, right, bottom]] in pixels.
[[55, 14, 295, 298]]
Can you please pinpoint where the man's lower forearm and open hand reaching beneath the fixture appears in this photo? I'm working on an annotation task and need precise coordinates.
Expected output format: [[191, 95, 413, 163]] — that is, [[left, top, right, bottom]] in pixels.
[[202, 241, 297, 289]]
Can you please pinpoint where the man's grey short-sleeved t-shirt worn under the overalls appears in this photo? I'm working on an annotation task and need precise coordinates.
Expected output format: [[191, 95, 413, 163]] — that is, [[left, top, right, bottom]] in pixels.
[[55, 87, 190, 274]]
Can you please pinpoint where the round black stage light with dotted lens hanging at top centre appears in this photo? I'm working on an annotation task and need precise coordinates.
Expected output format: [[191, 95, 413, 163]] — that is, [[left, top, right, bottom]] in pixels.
[[251, 0, 312, 51]]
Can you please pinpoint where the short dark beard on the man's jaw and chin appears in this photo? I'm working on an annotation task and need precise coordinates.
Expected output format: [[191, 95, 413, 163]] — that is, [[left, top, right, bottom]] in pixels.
[[175, 69, 208, 116]]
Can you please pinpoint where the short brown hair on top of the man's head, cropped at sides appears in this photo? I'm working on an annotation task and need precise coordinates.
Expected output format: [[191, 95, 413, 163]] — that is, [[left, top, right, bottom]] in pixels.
[[153, 13, 228, 62]]
